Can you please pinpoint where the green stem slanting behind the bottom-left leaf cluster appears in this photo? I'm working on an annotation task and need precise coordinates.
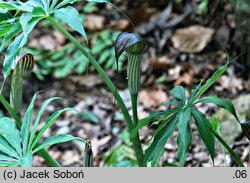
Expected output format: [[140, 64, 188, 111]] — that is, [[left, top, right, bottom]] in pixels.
[[0, 94, 61, 167]]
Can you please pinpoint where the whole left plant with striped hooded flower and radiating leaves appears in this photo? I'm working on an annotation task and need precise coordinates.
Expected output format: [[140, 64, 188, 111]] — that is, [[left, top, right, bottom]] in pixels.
[[0, 54, 90, 167]]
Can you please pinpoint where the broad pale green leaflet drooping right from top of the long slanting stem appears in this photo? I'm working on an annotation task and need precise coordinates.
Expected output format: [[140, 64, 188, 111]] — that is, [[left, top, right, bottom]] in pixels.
[[54, 6, 87, 40]]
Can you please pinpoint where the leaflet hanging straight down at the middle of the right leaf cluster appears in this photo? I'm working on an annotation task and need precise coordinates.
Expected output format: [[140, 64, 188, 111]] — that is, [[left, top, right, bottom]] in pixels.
[[177, 108, 192, 166]]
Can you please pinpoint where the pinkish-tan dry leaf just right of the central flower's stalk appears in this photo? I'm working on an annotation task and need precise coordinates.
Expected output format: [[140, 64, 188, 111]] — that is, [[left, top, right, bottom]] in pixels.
[[139, 87, 168, 108]]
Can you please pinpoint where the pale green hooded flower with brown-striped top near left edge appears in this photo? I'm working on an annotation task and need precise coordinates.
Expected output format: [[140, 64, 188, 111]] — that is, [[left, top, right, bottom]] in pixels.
[[10, 54, 35, 113]]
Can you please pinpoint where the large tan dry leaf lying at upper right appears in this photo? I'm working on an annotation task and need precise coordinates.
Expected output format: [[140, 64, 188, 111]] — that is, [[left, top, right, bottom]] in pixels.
[[171, 25, 214, 53]]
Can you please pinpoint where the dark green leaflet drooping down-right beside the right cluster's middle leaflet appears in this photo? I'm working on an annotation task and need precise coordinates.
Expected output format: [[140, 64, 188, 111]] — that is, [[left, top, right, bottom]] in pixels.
[[191, 109, 215, 162]]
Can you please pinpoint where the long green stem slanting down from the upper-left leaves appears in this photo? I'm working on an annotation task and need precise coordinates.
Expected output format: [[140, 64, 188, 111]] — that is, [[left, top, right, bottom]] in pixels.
[[47, 16, 146, 166]]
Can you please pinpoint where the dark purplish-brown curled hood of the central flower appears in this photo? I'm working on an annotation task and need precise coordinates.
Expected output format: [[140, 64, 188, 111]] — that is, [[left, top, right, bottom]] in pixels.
[[115, 32, 149, 60]]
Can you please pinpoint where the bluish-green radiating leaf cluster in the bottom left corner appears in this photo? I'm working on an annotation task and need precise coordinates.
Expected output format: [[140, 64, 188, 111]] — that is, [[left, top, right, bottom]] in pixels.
[[0, 94, 85, 167]]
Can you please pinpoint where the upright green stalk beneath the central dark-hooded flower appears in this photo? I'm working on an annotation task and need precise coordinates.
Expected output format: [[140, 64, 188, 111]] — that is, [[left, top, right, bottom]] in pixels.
[[131, 94, 145, 167]]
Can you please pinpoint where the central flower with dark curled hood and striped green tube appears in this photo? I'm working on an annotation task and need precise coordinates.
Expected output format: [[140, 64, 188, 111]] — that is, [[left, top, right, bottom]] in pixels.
[[115, 32, 149, 94]]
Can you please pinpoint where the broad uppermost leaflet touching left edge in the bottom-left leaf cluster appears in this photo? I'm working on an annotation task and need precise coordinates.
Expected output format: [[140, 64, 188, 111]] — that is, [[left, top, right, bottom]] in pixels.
[[0, 117, 22, 156]]
